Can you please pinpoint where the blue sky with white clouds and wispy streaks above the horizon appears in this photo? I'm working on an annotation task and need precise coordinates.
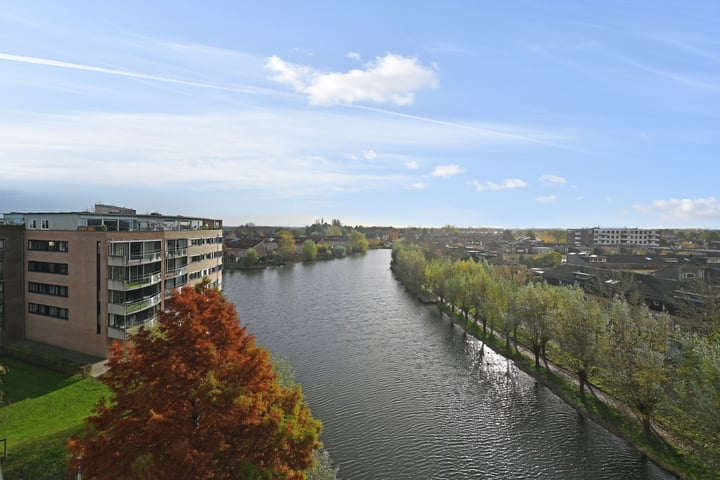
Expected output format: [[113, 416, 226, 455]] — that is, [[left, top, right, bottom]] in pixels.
[[0, 0, 720, 229]]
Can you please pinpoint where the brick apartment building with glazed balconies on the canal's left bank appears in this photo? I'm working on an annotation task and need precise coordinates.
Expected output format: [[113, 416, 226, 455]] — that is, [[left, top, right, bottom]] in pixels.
[[0, 205, 223, 357]]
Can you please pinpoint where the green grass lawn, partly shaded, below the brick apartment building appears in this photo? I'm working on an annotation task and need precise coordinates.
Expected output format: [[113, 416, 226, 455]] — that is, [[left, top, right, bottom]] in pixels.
[[0, 357, 108, 479]]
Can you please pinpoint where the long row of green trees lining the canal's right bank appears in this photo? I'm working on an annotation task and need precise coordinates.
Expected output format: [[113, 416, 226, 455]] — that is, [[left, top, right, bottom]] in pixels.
[[392, 238, 720, 478]]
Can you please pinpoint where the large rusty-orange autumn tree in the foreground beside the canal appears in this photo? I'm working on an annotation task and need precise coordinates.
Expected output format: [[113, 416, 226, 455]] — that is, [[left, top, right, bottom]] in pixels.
[[68, 287, 321, 480]]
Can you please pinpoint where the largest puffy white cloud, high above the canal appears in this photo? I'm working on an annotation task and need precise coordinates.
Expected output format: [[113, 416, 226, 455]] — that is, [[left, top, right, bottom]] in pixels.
[[265, 53, 437, 105]]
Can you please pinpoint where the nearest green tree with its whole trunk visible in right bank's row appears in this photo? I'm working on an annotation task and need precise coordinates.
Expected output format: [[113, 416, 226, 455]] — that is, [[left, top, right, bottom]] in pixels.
[[608, 297, 671, 435]]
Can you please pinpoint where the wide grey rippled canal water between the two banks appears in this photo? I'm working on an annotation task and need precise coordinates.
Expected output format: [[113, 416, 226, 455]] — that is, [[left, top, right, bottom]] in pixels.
[[223, 250, 674, 480]]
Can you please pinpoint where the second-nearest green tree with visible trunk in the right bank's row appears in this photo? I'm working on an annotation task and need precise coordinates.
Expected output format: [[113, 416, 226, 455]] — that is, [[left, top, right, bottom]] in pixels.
[[554, 287, 607, 395]]
